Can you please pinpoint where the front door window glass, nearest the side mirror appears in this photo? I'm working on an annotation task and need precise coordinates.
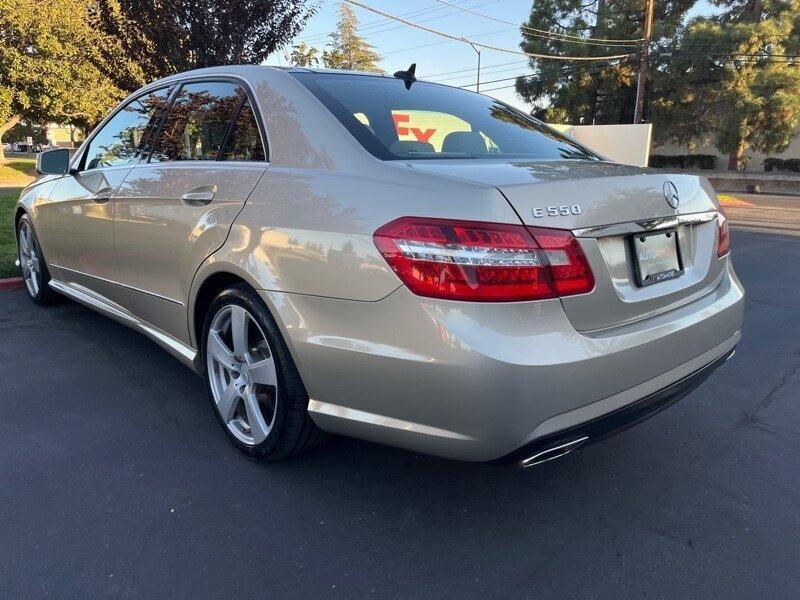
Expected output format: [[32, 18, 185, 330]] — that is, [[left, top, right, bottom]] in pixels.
[[85, 88, 169, 169]]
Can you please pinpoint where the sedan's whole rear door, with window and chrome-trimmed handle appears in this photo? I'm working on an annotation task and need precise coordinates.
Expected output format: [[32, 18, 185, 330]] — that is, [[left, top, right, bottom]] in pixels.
[[114, 80, 268, 341]]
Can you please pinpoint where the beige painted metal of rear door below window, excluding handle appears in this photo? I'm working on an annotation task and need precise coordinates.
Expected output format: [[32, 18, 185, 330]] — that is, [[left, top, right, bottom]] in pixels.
[[114, 161, 267, 343]]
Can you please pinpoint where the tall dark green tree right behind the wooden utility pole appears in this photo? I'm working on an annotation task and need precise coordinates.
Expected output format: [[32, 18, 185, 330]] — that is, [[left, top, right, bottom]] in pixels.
[[516, 0, 695, 124]]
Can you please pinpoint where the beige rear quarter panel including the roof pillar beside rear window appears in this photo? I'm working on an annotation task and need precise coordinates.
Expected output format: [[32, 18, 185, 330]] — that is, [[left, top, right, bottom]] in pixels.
[[190, 70, 520, 322]]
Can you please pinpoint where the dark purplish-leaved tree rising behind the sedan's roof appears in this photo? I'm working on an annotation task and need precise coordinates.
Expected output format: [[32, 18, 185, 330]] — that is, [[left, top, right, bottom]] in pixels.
[[92, 0, 317, 90]]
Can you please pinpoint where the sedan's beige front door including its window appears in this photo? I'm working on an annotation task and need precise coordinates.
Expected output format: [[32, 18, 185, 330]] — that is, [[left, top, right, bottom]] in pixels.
[[37, 89, 168, 300]]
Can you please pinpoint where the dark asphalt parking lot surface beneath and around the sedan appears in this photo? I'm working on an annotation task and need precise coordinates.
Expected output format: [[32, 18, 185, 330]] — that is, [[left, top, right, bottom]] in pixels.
[[0, 230, 800, 598]]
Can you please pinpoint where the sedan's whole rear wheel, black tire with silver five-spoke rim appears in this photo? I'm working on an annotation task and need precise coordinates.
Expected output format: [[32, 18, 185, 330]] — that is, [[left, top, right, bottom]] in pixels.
[[201, 284, 327, 462]]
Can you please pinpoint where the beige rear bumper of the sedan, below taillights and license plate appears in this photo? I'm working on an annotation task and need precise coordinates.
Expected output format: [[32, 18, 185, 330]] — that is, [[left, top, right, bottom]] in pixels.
[[262, 260, 744, 461]]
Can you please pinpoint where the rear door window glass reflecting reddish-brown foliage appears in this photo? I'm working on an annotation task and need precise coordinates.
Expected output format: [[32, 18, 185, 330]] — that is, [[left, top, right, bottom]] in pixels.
[[150, 82, 264, 162]]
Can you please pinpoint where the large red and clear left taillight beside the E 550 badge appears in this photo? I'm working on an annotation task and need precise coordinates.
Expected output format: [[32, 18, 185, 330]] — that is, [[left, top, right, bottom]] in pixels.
[[374, 217, 594, 302]]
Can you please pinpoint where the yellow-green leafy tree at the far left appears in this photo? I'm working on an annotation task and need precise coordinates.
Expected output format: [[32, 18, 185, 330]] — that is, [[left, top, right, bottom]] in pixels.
[[0, 0, 123, 162]]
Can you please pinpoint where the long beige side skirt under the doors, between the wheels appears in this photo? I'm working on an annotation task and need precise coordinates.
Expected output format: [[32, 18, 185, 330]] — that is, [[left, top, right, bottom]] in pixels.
[[50, 279, 200, 373]]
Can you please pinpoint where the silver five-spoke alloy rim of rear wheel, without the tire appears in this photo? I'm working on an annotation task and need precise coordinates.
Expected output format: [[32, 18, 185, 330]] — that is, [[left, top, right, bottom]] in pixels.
[[206, 304, 278, 446]]
